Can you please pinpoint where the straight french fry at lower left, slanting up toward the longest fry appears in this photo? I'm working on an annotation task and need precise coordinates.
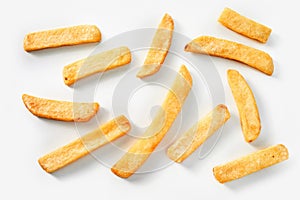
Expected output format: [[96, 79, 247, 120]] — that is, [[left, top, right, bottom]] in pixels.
[[38, 115, 130, 173]]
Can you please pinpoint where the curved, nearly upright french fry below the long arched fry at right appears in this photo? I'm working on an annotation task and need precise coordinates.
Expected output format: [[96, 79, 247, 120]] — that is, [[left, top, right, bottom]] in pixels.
[[227, 70, 261, 142]]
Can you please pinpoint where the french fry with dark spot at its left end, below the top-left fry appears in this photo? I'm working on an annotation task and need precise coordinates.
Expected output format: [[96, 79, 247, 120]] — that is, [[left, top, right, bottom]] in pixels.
[[63, 47, 131, 85]]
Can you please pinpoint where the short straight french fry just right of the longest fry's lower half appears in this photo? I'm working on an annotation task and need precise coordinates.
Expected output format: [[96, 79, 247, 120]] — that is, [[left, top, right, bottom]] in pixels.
[[167, 105, 230, 163]]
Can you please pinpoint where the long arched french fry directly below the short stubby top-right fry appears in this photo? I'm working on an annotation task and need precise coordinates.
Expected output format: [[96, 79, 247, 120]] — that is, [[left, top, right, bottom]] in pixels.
[[185, 36, 274, 75]]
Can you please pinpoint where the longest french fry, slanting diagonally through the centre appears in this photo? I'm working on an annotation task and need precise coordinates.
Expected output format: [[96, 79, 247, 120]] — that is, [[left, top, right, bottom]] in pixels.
[[111, 65, 192, 178]]
